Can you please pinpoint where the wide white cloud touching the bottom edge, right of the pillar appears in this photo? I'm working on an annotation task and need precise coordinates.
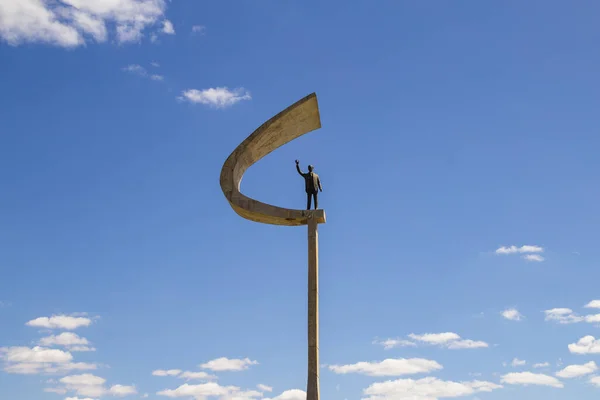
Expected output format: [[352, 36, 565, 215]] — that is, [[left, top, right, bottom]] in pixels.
[[363, 377, 502, 400]]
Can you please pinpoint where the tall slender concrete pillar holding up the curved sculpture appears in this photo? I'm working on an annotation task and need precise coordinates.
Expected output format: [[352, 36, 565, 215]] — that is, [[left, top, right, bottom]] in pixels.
[[306, 218, 320, 400]]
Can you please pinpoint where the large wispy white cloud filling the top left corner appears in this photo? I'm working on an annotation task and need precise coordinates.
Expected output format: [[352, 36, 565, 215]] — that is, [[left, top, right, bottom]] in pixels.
[[0, 0, 166, 47]]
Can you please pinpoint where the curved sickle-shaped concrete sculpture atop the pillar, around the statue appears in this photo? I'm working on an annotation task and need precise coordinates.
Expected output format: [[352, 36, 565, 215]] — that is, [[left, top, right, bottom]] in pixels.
[[221, 93, 325, 226]]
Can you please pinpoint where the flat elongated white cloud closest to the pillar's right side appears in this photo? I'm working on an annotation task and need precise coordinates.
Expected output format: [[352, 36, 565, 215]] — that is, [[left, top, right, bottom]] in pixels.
[[329, 358, 443, 376]]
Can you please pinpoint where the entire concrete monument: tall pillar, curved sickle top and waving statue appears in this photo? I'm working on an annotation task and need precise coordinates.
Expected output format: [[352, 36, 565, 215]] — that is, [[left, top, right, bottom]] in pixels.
[[221, 93, 325, 400]]
